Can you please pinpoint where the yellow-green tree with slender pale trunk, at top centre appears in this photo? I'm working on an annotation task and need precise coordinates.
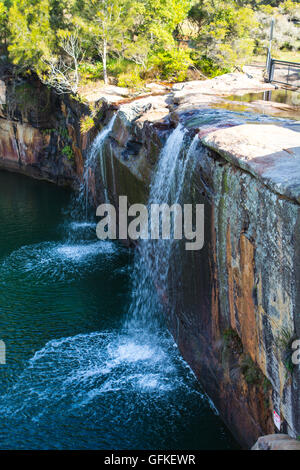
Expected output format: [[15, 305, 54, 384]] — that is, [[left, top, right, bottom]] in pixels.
[[74, 0, 191, 83]]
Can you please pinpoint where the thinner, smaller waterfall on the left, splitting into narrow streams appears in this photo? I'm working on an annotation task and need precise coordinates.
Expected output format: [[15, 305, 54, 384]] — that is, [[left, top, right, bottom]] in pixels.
[[79, 114, 117, 220]]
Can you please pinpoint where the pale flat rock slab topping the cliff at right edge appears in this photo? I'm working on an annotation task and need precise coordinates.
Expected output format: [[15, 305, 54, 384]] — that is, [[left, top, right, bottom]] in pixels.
[[202, 124, 300, 203]]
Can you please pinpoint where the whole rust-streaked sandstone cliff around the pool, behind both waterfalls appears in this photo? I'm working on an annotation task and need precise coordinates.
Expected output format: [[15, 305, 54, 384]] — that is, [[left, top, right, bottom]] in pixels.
[[0, 70, 300, 447]]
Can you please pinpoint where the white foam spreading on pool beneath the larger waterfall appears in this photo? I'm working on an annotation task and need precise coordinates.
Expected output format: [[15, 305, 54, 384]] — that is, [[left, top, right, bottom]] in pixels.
[[0, 332, 203, 420]]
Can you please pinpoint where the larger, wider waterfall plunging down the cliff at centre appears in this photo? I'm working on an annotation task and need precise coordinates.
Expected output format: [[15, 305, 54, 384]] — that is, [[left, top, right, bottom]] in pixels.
[[127, 124, 199, 331]]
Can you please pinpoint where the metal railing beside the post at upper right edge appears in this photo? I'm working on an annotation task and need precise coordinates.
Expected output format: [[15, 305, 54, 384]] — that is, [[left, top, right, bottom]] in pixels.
[[267, 57, 300, 88]]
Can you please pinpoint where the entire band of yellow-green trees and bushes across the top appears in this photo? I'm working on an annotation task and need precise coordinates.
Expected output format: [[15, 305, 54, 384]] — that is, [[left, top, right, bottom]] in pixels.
[[0, 0, 300, 91]]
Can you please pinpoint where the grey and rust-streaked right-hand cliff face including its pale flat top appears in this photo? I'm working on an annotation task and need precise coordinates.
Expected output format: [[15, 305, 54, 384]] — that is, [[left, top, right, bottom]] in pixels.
[[203, 125, 300, 437]]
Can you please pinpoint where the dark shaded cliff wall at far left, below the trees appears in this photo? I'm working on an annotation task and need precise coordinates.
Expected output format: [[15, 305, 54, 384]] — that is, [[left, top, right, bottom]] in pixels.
[[0, 71, 105, 186]]
